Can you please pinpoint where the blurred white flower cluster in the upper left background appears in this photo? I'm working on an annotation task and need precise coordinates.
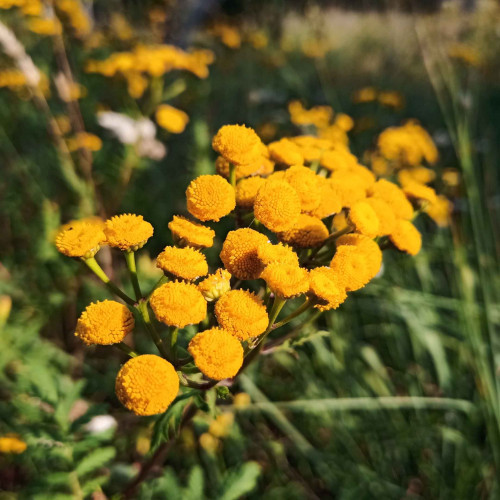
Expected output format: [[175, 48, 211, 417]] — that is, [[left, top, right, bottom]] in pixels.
[[97, 111, 167, 160]]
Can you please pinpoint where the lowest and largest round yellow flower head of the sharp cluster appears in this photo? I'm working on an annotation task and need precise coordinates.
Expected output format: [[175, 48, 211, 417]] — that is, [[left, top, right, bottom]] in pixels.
[[115, 354, 179, 416]]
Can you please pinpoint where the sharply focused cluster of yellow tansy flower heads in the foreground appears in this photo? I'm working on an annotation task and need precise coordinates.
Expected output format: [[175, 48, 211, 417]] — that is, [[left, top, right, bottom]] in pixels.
[[56, 125, 450, 432]]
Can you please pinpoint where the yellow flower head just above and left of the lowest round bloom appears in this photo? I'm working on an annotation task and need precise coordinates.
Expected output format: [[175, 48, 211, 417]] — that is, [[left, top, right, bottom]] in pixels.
[[75, 300, 135, 345]]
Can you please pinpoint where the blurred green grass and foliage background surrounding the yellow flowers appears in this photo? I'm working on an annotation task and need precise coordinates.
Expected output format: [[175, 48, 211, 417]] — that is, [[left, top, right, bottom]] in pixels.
[[0, 0, 500, 500]]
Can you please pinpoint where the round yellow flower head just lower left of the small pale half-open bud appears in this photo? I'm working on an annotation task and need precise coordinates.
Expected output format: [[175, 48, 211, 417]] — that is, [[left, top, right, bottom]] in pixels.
[[149, 281, 207, 328]]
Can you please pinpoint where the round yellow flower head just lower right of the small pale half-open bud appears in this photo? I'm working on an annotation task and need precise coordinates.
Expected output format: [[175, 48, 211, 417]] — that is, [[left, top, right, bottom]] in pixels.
[[215, 290, 269, 340]]
